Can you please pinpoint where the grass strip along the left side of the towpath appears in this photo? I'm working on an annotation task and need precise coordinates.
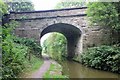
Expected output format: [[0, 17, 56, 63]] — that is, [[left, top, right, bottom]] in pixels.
[[20, 55, 43, 78]]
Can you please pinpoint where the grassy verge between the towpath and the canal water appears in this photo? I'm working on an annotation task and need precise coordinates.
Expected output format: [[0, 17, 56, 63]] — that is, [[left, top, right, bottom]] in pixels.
[[43, 63, 68, 78]]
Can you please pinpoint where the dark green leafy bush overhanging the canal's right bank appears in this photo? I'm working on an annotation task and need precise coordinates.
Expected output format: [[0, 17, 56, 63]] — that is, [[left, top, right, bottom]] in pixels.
[[81, 46, 120, 73]]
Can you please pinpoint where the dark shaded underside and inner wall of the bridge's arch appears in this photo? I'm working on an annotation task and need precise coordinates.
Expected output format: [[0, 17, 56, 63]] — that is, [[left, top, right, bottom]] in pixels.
[[40, 23, 81, 58]]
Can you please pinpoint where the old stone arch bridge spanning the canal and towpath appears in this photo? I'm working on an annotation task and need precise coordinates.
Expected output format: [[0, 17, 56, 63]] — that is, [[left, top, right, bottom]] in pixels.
[[3, 7, 119, 58]]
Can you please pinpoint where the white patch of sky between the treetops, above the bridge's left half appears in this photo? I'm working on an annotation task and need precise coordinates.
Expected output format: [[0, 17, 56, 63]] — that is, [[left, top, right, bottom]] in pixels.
[[32, 0, 60, 10]]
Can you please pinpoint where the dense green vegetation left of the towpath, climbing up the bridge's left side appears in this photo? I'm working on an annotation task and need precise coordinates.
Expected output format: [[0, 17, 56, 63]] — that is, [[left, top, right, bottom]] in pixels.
[[2, 21, 41, 79]]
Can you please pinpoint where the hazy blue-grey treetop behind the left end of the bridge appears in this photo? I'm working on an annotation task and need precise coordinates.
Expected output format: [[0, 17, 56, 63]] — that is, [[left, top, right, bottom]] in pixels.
[[6, 0, 34, 12]]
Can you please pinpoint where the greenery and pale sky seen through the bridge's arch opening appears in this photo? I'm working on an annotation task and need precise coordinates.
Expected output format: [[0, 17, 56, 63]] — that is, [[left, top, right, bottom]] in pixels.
[[40, 32, 67, 60]]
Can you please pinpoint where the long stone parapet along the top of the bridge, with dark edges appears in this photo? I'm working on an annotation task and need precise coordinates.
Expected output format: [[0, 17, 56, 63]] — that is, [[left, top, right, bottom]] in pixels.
[[10, 7, 87, 19]]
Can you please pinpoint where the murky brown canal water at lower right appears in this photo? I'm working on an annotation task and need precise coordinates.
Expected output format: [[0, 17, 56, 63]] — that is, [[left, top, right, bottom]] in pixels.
[[61, 60, 120, 78]]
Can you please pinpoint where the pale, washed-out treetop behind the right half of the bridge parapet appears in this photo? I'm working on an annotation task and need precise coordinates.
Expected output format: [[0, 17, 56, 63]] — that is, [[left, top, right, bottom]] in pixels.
[[55, 0, 86, 9]]
